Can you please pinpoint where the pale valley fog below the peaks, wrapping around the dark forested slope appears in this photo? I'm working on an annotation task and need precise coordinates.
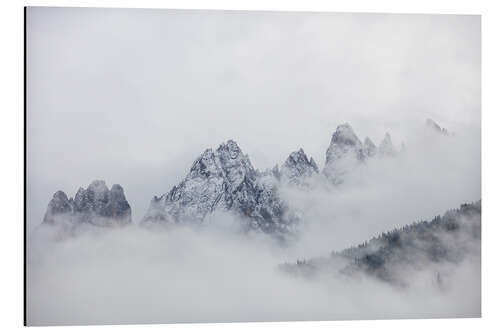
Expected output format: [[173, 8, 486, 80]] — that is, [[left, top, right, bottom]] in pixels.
[[27, 124, 481, 325]]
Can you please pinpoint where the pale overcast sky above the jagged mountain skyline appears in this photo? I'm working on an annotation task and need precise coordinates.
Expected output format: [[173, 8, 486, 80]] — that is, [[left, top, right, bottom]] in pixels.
[[27, 8, 481, 229]]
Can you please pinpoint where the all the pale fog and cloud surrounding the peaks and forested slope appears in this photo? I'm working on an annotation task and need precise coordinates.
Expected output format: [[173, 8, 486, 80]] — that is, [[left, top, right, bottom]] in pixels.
[[27, 7, 481, 325]]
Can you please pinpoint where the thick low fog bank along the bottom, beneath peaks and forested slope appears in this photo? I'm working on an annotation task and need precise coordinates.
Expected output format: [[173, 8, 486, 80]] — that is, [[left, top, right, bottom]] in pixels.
[[27, 220, 480, 325]]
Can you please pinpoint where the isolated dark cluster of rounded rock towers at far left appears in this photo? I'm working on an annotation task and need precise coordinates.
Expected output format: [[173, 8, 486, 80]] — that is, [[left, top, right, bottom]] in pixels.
[[43, 180, 131, 226]]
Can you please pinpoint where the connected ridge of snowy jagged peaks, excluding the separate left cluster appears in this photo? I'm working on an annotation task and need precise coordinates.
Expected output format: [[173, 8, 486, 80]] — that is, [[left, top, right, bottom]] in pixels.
[[141, 124, 402, 234]]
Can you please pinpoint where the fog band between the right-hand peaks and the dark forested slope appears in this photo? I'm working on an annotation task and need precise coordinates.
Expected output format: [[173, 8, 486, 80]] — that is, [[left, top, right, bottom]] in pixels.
[[282, 124, 481, 256]]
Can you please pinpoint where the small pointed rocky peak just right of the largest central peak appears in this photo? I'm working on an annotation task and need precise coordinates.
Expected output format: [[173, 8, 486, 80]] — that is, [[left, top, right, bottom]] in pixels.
[[279, 148, 319, 186]]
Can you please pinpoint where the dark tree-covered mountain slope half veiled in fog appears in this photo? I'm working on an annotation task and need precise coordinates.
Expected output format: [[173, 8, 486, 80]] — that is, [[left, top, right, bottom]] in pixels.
[[281, 201, 481, 286]]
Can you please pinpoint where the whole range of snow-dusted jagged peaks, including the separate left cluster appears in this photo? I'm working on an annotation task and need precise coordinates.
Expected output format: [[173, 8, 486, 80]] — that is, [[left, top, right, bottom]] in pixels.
[[43, 123, 430, 236]]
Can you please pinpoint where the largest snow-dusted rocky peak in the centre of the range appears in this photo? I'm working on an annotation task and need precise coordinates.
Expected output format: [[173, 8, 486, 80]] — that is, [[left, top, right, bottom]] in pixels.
[[141, 140, 294, 234]]
